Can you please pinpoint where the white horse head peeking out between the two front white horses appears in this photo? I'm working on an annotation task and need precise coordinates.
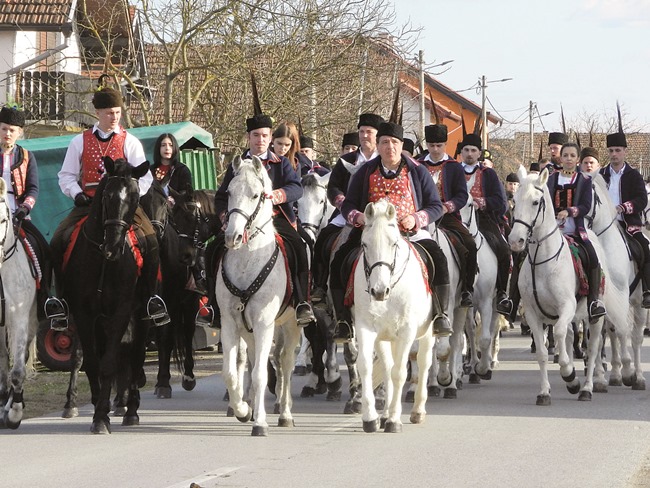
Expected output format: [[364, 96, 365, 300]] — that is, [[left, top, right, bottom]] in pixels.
[[298, 173, 334, 242]]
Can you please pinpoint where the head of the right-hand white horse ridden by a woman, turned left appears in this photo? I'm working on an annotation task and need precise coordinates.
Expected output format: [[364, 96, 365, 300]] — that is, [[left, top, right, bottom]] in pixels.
[[508, 168, 557, 251]]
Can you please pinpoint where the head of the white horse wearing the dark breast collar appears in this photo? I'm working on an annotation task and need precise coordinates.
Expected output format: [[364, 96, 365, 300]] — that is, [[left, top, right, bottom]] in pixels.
[[225, 156, 273, 249]]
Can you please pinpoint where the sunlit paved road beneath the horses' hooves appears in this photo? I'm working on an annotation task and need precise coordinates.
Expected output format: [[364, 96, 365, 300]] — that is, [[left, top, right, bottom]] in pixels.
[[0, 329, 650, 488]]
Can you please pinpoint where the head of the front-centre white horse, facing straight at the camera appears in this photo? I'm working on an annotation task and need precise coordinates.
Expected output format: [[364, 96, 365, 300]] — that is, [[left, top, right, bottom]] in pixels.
[[361, 200, 402, 301]]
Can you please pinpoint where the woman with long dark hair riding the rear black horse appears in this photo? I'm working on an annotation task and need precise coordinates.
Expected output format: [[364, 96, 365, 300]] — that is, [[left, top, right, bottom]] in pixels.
[[151, 133, 213, 326]]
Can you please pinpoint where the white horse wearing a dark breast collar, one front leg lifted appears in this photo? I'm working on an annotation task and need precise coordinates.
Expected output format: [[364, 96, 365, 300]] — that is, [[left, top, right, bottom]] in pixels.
[[216, 156, 300, 436]]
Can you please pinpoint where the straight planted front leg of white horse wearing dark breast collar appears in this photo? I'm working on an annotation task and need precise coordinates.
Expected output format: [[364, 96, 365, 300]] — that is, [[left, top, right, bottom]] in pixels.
[[248, 323, 275, 436]]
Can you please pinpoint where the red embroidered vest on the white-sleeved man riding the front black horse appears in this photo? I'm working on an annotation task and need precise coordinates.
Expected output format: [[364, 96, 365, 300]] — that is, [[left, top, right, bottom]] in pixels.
[[81, 132, 126, 197]]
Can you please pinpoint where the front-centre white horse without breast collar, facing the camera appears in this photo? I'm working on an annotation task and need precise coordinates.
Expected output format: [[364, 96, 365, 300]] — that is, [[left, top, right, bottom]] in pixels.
[[352, 201, 433, 432]]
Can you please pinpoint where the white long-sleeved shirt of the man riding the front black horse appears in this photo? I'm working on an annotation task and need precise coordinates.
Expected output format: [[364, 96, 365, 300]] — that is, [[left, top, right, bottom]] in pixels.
[[58, 124, 153, 199]]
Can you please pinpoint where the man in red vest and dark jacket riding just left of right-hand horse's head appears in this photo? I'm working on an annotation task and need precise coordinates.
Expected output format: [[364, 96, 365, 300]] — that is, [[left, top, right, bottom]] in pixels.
[[460, 129, 513, 316]]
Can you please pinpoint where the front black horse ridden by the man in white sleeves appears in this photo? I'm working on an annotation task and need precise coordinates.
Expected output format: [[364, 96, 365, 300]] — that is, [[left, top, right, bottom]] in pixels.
[[61, 158, 153, 433]]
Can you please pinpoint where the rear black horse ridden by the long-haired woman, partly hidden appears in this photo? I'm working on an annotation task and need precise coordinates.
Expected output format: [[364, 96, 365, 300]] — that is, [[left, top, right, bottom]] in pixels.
[[142, 181, 214, 398]]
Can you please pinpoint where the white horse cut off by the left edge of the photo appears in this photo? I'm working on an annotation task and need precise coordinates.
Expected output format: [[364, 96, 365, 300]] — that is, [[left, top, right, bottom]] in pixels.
[[0, 178, 38, 429]]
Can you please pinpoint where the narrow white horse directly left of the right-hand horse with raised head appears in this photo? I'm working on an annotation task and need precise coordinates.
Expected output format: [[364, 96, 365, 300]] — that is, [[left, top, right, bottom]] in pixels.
[[460, 195, 499, 383]]
